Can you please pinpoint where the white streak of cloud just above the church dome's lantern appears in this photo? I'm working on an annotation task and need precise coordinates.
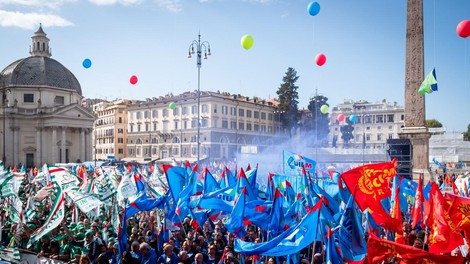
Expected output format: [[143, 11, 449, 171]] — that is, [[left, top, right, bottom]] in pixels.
[[0, 10, 74, 29]]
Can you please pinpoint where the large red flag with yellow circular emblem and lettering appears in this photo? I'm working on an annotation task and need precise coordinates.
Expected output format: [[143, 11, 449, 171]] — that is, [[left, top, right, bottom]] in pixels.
[[338, 159, 402, 232]]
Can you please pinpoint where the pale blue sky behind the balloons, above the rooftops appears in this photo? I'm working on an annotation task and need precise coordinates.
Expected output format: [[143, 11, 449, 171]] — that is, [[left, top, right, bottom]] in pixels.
[[0, 0, 470, 132]]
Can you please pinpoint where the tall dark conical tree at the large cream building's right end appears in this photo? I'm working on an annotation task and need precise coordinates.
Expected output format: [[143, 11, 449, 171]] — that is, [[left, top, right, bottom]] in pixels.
[[277, 67, 300, 135]]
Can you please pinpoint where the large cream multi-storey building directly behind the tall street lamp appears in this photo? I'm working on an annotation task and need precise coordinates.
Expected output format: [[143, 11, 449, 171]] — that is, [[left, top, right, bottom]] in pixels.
[[125, 91, 282, 161]]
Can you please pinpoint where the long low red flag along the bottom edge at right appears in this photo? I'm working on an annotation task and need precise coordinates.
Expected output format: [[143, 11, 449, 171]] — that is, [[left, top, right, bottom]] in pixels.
[[367, 233, 465, 264]]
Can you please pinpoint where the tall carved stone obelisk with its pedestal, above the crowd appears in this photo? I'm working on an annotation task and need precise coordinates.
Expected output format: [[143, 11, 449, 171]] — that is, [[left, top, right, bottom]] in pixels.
[[399, 0, 430, 182]]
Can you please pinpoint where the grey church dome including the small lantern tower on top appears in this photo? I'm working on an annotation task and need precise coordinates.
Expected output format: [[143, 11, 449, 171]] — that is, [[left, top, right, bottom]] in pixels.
[[0, 25, 82, 95]]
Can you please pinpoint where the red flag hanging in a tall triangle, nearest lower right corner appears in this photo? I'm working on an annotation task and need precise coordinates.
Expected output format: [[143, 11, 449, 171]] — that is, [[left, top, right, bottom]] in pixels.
[[426, 183, 463, 253]]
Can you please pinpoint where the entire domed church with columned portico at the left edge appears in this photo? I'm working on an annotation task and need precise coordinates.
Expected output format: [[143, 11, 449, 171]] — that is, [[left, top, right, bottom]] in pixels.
[[0, 26, 95, 167]]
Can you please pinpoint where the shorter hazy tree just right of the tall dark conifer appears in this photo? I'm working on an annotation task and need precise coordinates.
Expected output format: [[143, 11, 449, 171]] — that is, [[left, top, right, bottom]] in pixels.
[[307, 95, 330, 146]]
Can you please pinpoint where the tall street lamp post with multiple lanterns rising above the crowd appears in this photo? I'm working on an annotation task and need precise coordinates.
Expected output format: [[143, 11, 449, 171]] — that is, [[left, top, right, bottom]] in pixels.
[[188, 33, 211, 168]]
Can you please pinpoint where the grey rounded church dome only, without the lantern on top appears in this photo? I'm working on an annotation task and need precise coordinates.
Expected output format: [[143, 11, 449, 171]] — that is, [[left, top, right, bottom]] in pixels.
[[0, 56, 82, 95]]
